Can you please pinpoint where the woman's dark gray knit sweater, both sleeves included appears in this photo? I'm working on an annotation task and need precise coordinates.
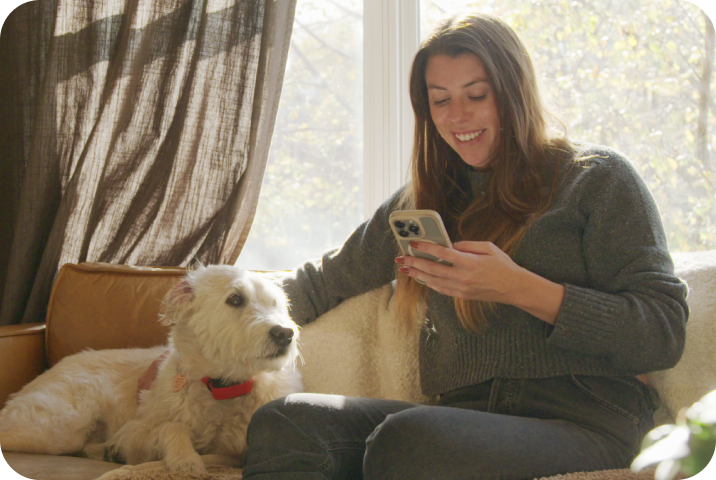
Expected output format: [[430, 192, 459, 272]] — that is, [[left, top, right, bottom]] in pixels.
[[284, 145, 688, 395]]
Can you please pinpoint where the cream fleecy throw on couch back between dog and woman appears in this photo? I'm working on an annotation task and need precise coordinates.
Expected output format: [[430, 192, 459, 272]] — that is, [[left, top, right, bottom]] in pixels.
[[299, 285, 432, 403]]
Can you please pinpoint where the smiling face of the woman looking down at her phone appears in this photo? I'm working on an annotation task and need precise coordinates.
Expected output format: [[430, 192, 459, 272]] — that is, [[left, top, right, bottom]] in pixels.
[[425, 53, 500, 169]]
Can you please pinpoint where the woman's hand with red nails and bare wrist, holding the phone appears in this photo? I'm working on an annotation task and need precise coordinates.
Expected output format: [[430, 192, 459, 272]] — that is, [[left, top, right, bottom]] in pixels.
[[395, 242, 564, 325]]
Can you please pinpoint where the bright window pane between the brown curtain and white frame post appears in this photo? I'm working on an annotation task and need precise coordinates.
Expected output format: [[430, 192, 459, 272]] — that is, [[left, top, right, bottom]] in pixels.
[[237, 0, 363, 270]]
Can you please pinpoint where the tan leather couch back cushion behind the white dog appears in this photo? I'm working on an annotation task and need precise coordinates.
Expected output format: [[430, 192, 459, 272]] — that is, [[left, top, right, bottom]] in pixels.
[[45, 263, 185, 366]]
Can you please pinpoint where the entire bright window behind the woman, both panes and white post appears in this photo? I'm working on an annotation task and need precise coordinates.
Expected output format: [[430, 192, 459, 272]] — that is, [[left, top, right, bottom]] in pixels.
[[237, 0, 716, 269]]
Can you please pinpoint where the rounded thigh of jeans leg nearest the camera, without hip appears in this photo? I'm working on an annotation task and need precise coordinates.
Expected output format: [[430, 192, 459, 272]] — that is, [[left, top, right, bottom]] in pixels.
[[363, 407, 624, 480]]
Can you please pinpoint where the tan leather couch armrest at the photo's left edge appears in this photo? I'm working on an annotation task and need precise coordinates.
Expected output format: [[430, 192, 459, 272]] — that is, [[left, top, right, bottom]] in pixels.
[[0, 323, 46, 408]]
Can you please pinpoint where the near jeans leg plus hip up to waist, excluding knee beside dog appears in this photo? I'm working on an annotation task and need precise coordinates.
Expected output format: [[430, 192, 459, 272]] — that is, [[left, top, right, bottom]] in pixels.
[[364, 376, 656, 480]]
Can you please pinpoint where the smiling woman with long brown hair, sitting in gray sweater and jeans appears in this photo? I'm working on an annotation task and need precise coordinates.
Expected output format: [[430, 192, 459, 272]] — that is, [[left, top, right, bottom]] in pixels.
[[244, 15, 688, 480]]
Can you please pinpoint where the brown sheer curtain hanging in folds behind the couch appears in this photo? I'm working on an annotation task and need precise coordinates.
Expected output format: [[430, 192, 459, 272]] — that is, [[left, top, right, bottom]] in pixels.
[[0, 0, 296, 325]]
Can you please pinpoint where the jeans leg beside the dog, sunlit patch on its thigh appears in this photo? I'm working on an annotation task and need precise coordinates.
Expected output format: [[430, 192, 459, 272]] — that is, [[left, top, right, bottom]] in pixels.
[[243, 393, 419, 480]]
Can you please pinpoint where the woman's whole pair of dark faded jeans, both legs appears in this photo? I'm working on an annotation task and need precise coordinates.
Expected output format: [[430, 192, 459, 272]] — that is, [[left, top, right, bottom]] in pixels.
[[243, 375, 659, 480]]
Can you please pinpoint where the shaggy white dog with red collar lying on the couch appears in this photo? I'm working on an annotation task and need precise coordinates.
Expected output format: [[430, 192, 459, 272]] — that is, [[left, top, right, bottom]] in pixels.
[[0, 265, 302, 473]]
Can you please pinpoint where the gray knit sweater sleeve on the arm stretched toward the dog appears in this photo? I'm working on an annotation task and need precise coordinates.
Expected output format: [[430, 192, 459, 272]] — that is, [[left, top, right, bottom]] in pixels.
[[283, 190, 402, 325]]
